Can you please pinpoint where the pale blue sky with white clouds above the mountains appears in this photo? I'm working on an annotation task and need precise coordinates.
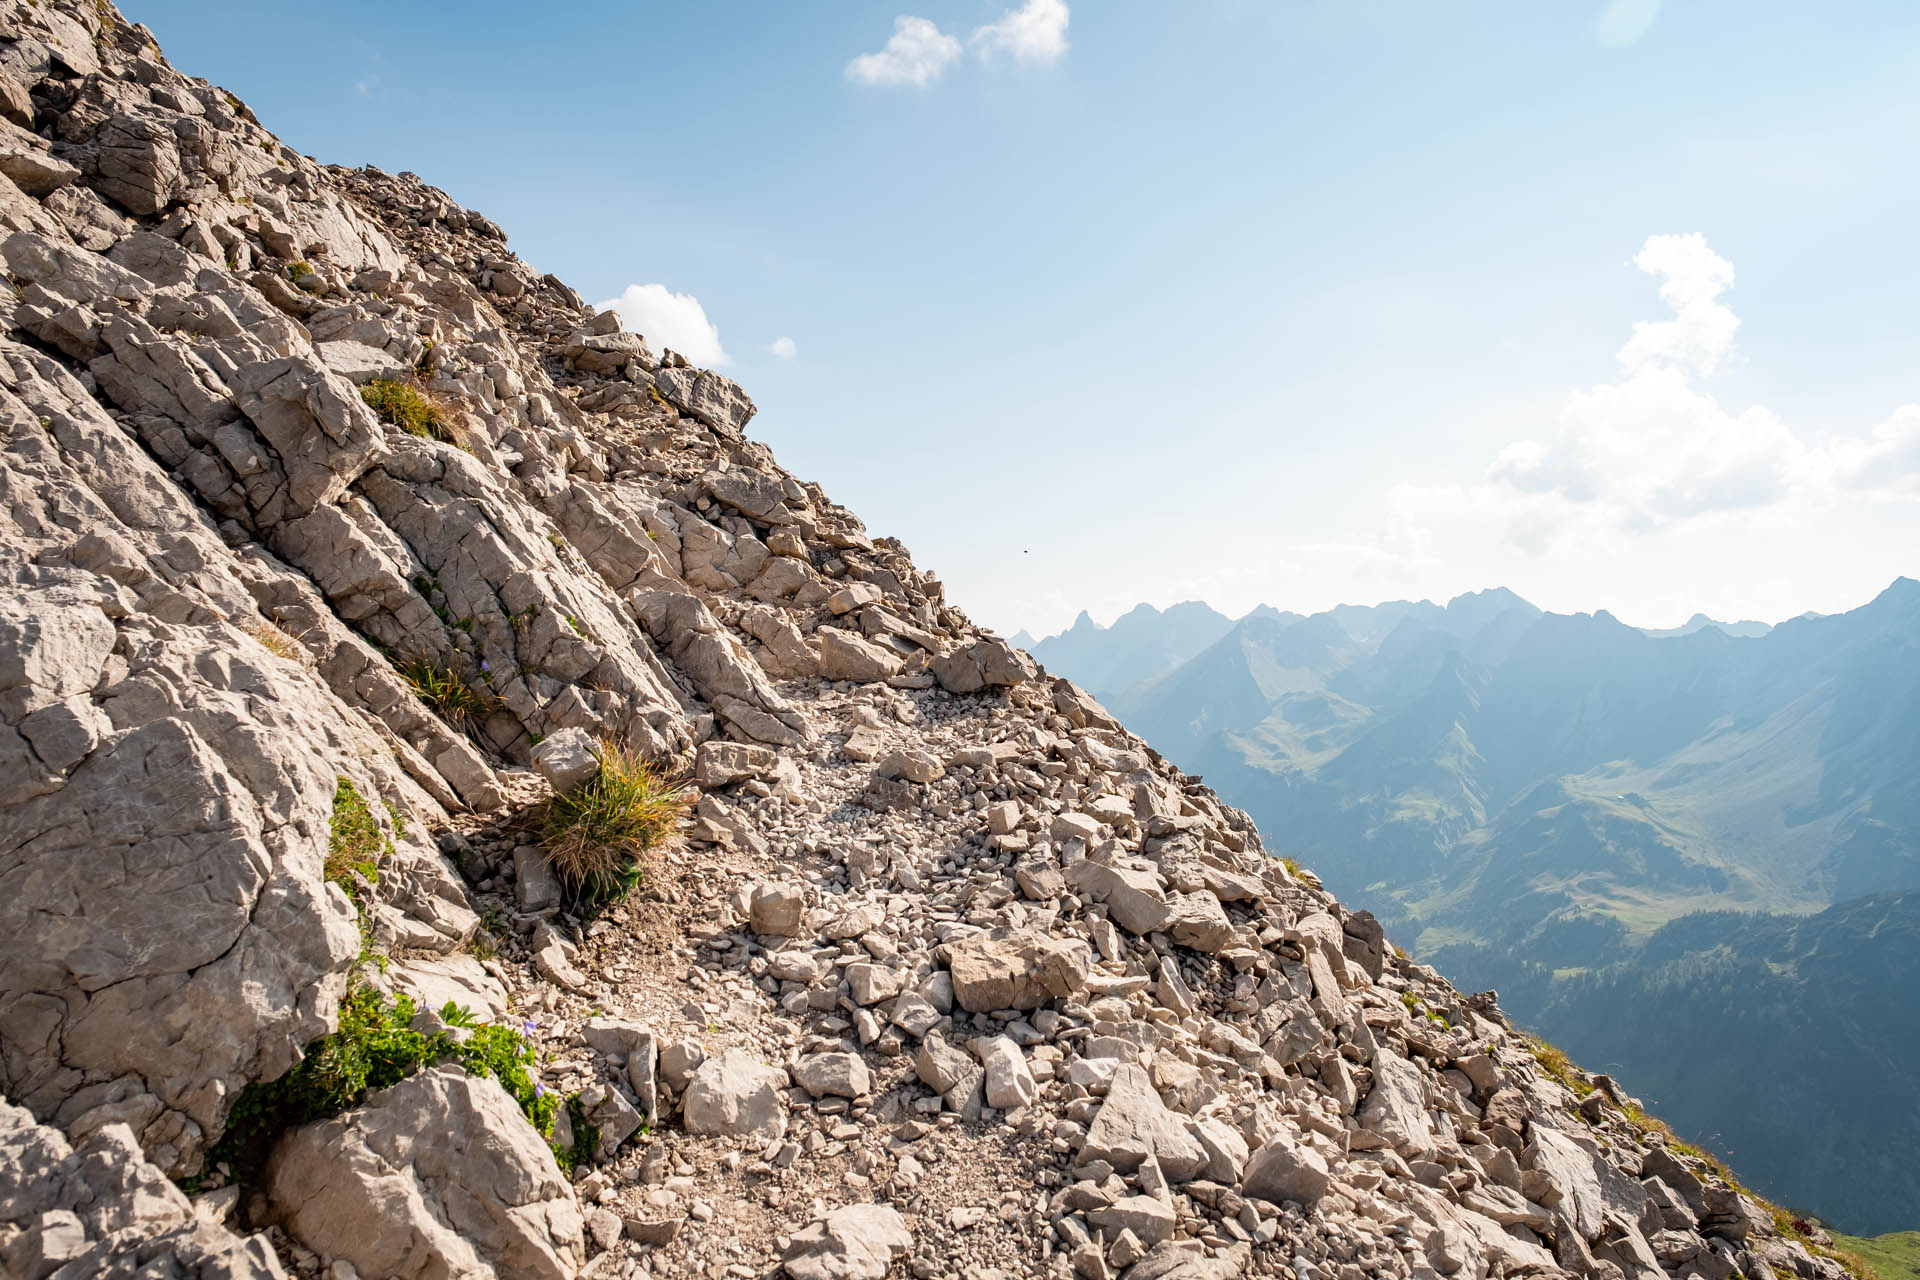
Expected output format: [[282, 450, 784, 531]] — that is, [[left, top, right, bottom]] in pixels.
[[125, 0, 1920, 633]]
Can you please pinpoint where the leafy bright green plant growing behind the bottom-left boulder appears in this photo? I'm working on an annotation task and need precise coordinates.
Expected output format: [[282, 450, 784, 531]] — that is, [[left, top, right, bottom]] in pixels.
[[207, 984, 559, 1180]]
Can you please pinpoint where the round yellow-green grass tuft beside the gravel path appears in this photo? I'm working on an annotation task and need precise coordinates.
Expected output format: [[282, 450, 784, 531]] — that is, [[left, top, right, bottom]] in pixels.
[[540, 739, 689, 906]]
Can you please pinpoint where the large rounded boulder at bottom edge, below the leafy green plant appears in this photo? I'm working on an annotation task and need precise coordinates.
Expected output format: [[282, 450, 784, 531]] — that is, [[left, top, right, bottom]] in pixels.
[[267, 1067, 582, 1280]]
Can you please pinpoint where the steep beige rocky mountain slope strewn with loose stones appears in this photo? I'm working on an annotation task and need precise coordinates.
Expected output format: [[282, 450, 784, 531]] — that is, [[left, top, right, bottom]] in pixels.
[[0, 0, 1873, 1280]]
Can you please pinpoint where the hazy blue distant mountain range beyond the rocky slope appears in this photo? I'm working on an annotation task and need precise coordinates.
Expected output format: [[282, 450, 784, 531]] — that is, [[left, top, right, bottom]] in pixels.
[[1029, 578, 1920, 1232]]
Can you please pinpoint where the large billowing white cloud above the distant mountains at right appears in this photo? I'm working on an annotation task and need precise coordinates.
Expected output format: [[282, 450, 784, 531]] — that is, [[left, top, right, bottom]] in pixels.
[[1382, 234, 1920, 560]]
